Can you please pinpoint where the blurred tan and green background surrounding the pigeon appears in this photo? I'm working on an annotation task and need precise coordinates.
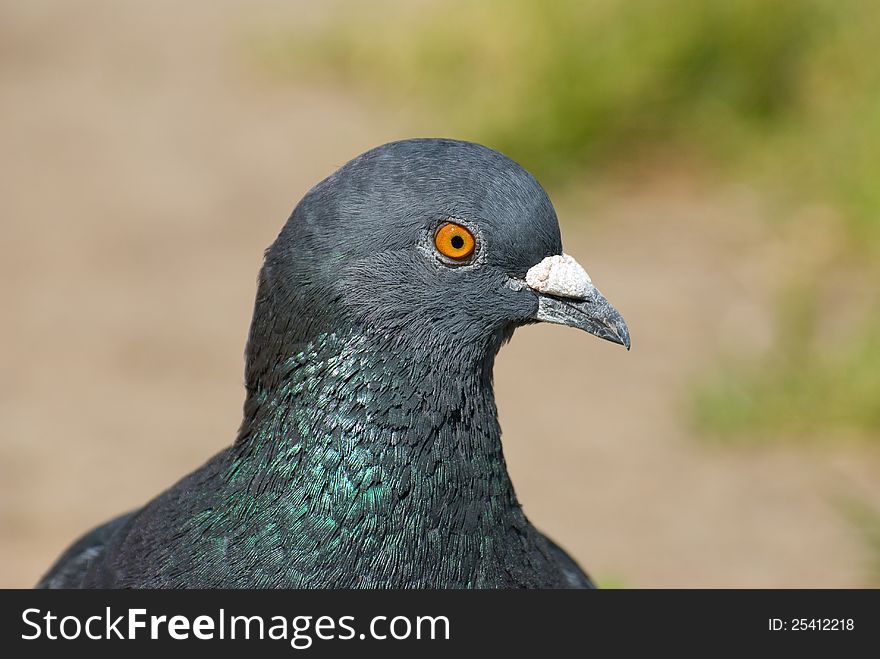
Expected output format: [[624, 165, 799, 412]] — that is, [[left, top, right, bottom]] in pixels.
[[0, 0, 880, 587]]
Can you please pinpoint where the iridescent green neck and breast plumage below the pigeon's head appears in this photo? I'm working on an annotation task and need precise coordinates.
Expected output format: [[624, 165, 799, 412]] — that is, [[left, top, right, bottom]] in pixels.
[[211, 333, 560, 586]]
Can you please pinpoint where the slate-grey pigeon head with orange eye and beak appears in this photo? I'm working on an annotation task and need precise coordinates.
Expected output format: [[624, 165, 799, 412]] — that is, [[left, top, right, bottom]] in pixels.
[[249, 139, 629, 390]]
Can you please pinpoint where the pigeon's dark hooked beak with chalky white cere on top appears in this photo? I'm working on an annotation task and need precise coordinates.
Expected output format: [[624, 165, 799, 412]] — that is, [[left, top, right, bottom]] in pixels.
[[526, 254, 630, 350]]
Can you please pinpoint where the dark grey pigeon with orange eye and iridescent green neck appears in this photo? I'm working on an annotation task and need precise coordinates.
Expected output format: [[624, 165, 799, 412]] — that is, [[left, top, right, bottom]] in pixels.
[[37, 138, 630, 589]]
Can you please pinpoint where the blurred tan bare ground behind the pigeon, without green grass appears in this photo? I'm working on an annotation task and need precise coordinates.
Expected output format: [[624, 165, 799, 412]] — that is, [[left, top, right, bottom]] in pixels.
[[0, 1, 880, 587]]
